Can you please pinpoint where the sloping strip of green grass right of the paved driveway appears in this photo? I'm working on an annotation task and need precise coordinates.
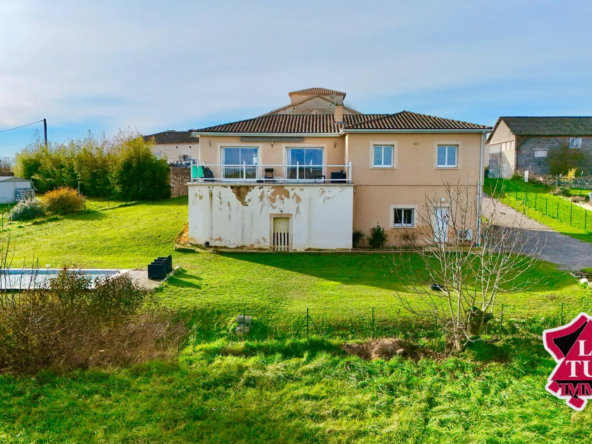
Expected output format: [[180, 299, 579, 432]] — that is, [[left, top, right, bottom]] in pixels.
[[484, 179, 592, 243]]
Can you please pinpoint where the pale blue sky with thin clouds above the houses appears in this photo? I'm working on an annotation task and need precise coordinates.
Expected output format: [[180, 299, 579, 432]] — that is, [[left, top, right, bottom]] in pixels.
[[0, 0, 592, 156]]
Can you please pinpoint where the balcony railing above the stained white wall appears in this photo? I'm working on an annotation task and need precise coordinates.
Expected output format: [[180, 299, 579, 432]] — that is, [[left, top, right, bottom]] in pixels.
[[191, 162, 352, 183]]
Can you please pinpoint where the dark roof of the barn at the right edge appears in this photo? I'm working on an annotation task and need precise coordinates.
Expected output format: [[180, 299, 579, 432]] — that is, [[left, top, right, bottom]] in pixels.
[[496, 117, 592, 136]]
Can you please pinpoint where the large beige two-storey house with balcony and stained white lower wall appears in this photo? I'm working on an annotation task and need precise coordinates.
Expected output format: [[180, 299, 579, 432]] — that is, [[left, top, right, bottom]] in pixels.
[[188, 88, 491, 251]]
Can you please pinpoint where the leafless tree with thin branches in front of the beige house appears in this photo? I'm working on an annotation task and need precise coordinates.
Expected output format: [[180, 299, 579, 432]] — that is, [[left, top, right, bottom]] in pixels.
[[393, 182, 538, 352]]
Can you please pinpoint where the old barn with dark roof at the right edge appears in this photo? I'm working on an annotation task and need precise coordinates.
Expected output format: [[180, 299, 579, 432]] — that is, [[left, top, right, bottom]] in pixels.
[[487, 117, 592, 178]]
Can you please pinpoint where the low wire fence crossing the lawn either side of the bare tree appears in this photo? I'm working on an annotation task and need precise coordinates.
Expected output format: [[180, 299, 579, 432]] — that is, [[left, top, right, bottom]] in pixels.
[[183, 303, 582, 342]]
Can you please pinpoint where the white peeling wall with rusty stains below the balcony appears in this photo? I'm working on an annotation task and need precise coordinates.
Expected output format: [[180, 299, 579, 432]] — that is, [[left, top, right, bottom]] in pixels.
[[189, 184, 353, 251]]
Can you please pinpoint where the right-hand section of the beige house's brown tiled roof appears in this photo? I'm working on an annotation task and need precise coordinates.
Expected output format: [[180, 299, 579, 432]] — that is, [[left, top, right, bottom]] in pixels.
[[345, 111, 491, 130]]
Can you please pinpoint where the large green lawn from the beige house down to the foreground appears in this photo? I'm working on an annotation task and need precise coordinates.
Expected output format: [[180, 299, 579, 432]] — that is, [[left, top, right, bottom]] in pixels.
[[0, 198, 592, 443]]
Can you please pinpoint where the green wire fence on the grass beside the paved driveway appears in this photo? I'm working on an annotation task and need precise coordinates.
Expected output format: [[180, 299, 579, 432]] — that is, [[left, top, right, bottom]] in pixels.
[[492, 181, 592, 233]]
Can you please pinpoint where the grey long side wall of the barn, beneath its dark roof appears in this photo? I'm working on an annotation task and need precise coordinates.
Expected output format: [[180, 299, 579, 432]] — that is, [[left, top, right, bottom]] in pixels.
[[516, 137, 592, 175]]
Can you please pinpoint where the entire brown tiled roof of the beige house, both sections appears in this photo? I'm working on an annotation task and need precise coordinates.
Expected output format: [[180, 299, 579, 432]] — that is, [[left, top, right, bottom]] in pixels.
[[193, 111, 491, 134]]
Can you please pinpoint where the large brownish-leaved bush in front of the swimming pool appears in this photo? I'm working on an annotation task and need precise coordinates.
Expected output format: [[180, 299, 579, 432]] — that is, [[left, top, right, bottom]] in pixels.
[[0, 270, 185, 373]]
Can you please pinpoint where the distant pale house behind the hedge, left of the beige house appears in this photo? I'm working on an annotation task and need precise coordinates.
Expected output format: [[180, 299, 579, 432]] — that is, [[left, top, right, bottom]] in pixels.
[[144, 130, 199, 163]]
